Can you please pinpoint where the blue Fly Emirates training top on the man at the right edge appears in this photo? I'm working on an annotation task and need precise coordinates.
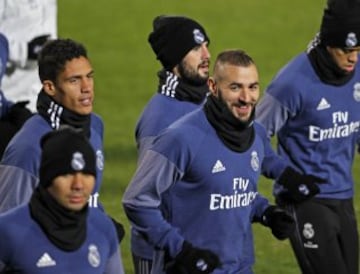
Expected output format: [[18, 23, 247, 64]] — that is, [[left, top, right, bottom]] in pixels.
[[256, 53, 360, 199]]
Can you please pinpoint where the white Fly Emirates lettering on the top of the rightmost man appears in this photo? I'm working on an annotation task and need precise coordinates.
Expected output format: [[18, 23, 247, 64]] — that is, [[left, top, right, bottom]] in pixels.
[[309, 111, 360, 142]]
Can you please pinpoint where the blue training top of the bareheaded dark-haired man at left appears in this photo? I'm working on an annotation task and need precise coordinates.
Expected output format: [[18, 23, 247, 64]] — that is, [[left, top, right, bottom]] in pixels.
[[0, 114, 104, 212]]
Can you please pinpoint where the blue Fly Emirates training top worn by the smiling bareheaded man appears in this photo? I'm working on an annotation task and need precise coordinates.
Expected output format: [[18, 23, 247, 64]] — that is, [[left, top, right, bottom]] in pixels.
[[123, 109, 282, 274]]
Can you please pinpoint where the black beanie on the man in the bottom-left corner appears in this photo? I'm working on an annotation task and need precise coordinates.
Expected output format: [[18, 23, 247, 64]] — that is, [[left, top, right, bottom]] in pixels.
[[40, 126, 96, 187]]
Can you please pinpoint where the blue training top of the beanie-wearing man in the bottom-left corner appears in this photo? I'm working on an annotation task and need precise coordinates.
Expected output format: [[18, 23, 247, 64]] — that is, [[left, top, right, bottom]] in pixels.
[[0, 205, 124, 274]]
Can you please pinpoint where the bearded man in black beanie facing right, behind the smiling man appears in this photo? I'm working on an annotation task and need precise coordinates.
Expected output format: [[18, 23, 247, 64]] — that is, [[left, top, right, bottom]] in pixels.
[[131, 15, 210, 274]]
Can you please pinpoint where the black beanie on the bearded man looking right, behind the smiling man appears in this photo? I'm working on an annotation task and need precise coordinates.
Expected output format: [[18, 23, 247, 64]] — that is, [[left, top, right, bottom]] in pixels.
[[148, 15, 210, 70]]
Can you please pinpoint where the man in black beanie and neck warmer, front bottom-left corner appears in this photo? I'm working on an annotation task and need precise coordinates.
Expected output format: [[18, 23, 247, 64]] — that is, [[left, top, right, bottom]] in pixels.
[[0, 127, 124, 274]]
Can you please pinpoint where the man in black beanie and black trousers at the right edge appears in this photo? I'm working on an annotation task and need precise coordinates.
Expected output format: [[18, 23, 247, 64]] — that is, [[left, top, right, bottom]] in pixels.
[[256, 0, 360, 274]]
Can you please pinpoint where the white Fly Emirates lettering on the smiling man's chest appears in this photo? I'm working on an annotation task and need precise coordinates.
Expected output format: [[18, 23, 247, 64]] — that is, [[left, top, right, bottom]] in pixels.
[[210, 177, 258, 210]]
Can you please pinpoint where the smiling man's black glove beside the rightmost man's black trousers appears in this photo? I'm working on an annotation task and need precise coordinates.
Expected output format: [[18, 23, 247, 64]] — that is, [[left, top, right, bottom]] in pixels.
[[261, 205, 295, 240]]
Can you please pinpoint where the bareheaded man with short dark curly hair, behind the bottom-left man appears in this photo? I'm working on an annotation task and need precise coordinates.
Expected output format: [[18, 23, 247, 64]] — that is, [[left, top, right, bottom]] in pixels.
[[0, 39, 123, 242]]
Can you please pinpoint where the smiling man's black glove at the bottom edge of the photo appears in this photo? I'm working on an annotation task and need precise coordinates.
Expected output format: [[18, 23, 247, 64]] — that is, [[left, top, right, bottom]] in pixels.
[[165, 241, 221, 274]]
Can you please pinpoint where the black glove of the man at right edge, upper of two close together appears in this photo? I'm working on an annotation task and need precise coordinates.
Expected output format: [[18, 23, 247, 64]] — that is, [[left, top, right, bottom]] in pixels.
[[278, 167, 325, 203]]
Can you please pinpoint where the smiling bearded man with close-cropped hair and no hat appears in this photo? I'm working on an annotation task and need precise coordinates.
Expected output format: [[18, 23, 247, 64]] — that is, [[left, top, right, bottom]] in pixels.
[[123, 50, 294, 274]]
